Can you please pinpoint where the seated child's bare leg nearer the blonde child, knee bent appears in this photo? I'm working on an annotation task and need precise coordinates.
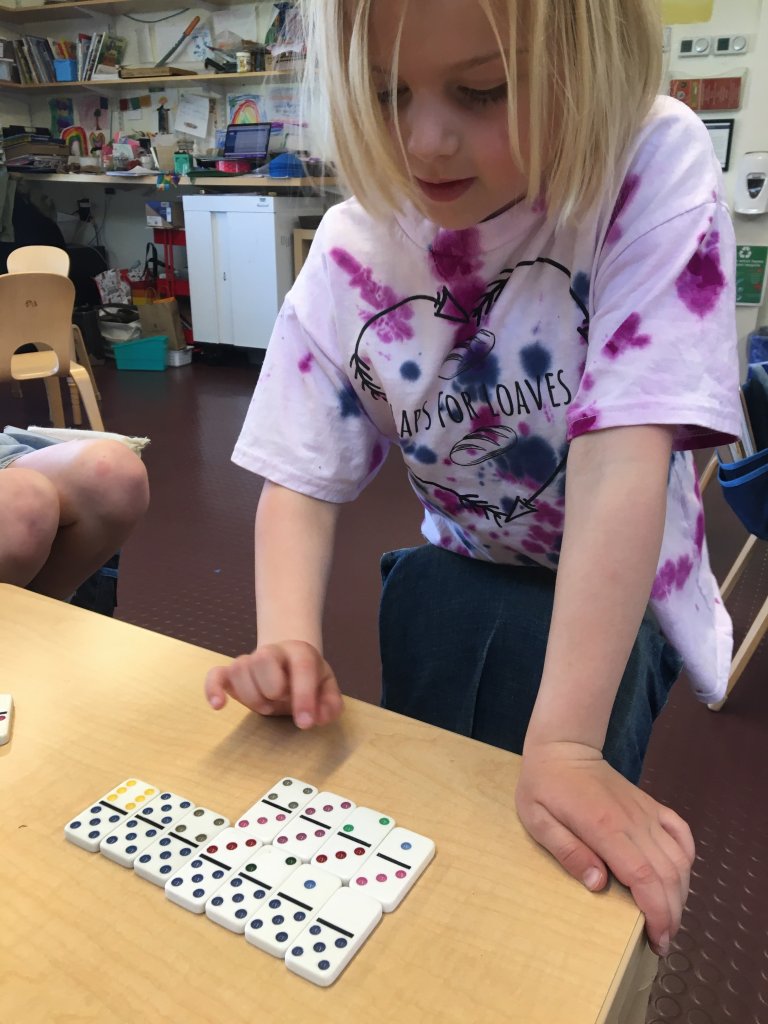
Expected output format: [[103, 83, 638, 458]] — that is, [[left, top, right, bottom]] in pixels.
[[4, 440, 150, 598]]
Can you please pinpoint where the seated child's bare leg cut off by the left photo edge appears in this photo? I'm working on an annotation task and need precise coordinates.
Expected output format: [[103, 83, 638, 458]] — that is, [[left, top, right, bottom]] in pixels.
[[0, 468, 59, 587]]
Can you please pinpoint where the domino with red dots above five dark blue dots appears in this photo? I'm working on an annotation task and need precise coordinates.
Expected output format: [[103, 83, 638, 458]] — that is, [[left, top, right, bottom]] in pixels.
[[165, 828, 262, 913]]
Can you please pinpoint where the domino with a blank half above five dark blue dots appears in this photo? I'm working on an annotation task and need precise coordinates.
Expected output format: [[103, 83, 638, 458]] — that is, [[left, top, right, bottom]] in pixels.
[[286, 886, 382, 987]]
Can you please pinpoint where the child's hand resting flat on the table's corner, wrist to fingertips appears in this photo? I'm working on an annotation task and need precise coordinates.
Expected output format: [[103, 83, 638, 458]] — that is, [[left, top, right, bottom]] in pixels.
[[516, 742, 695, 956]]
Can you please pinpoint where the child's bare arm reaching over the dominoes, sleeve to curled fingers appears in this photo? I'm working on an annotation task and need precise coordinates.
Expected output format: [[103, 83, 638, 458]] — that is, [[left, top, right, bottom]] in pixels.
[[206, 480, 342, 729]]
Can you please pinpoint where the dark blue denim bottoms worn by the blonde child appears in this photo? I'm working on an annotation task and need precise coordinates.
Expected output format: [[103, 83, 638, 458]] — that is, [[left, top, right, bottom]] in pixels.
[[379, 544, 682, 782]]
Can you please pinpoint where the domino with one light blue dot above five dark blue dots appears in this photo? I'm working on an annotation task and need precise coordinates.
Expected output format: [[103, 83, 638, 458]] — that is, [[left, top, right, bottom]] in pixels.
[[245, 864, 341, 957]]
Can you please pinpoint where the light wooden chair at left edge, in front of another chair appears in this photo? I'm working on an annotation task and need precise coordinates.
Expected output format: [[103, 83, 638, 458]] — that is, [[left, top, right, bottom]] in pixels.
[[0, 273, 104, 430]]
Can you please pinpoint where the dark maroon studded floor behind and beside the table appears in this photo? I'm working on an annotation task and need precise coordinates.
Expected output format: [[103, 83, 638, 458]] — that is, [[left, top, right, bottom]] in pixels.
[[0, 352, 768, 1024]]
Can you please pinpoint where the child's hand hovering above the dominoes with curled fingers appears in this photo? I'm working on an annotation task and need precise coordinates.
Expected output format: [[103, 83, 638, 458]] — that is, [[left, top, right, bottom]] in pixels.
[[205, 640, 343, 729]]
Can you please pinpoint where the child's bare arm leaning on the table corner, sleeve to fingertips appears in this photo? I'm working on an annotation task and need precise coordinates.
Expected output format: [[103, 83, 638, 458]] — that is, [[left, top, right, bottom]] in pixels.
[[516, 426, 694, 954]]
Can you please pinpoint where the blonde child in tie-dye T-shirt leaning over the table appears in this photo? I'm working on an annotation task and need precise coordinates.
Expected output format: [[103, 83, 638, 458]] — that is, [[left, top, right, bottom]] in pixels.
[[206, 0, 738, 954]]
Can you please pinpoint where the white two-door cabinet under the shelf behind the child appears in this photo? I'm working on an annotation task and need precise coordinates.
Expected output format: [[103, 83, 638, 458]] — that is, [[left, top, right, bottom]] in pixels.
[[183, 195, 324, 348]]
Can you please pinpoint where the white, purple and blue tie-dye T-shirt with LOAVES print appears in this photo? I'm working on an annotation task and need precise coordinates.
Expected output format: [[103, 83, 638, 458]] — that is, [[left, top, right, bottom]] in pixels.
[[233, 97, 739, 700]]
